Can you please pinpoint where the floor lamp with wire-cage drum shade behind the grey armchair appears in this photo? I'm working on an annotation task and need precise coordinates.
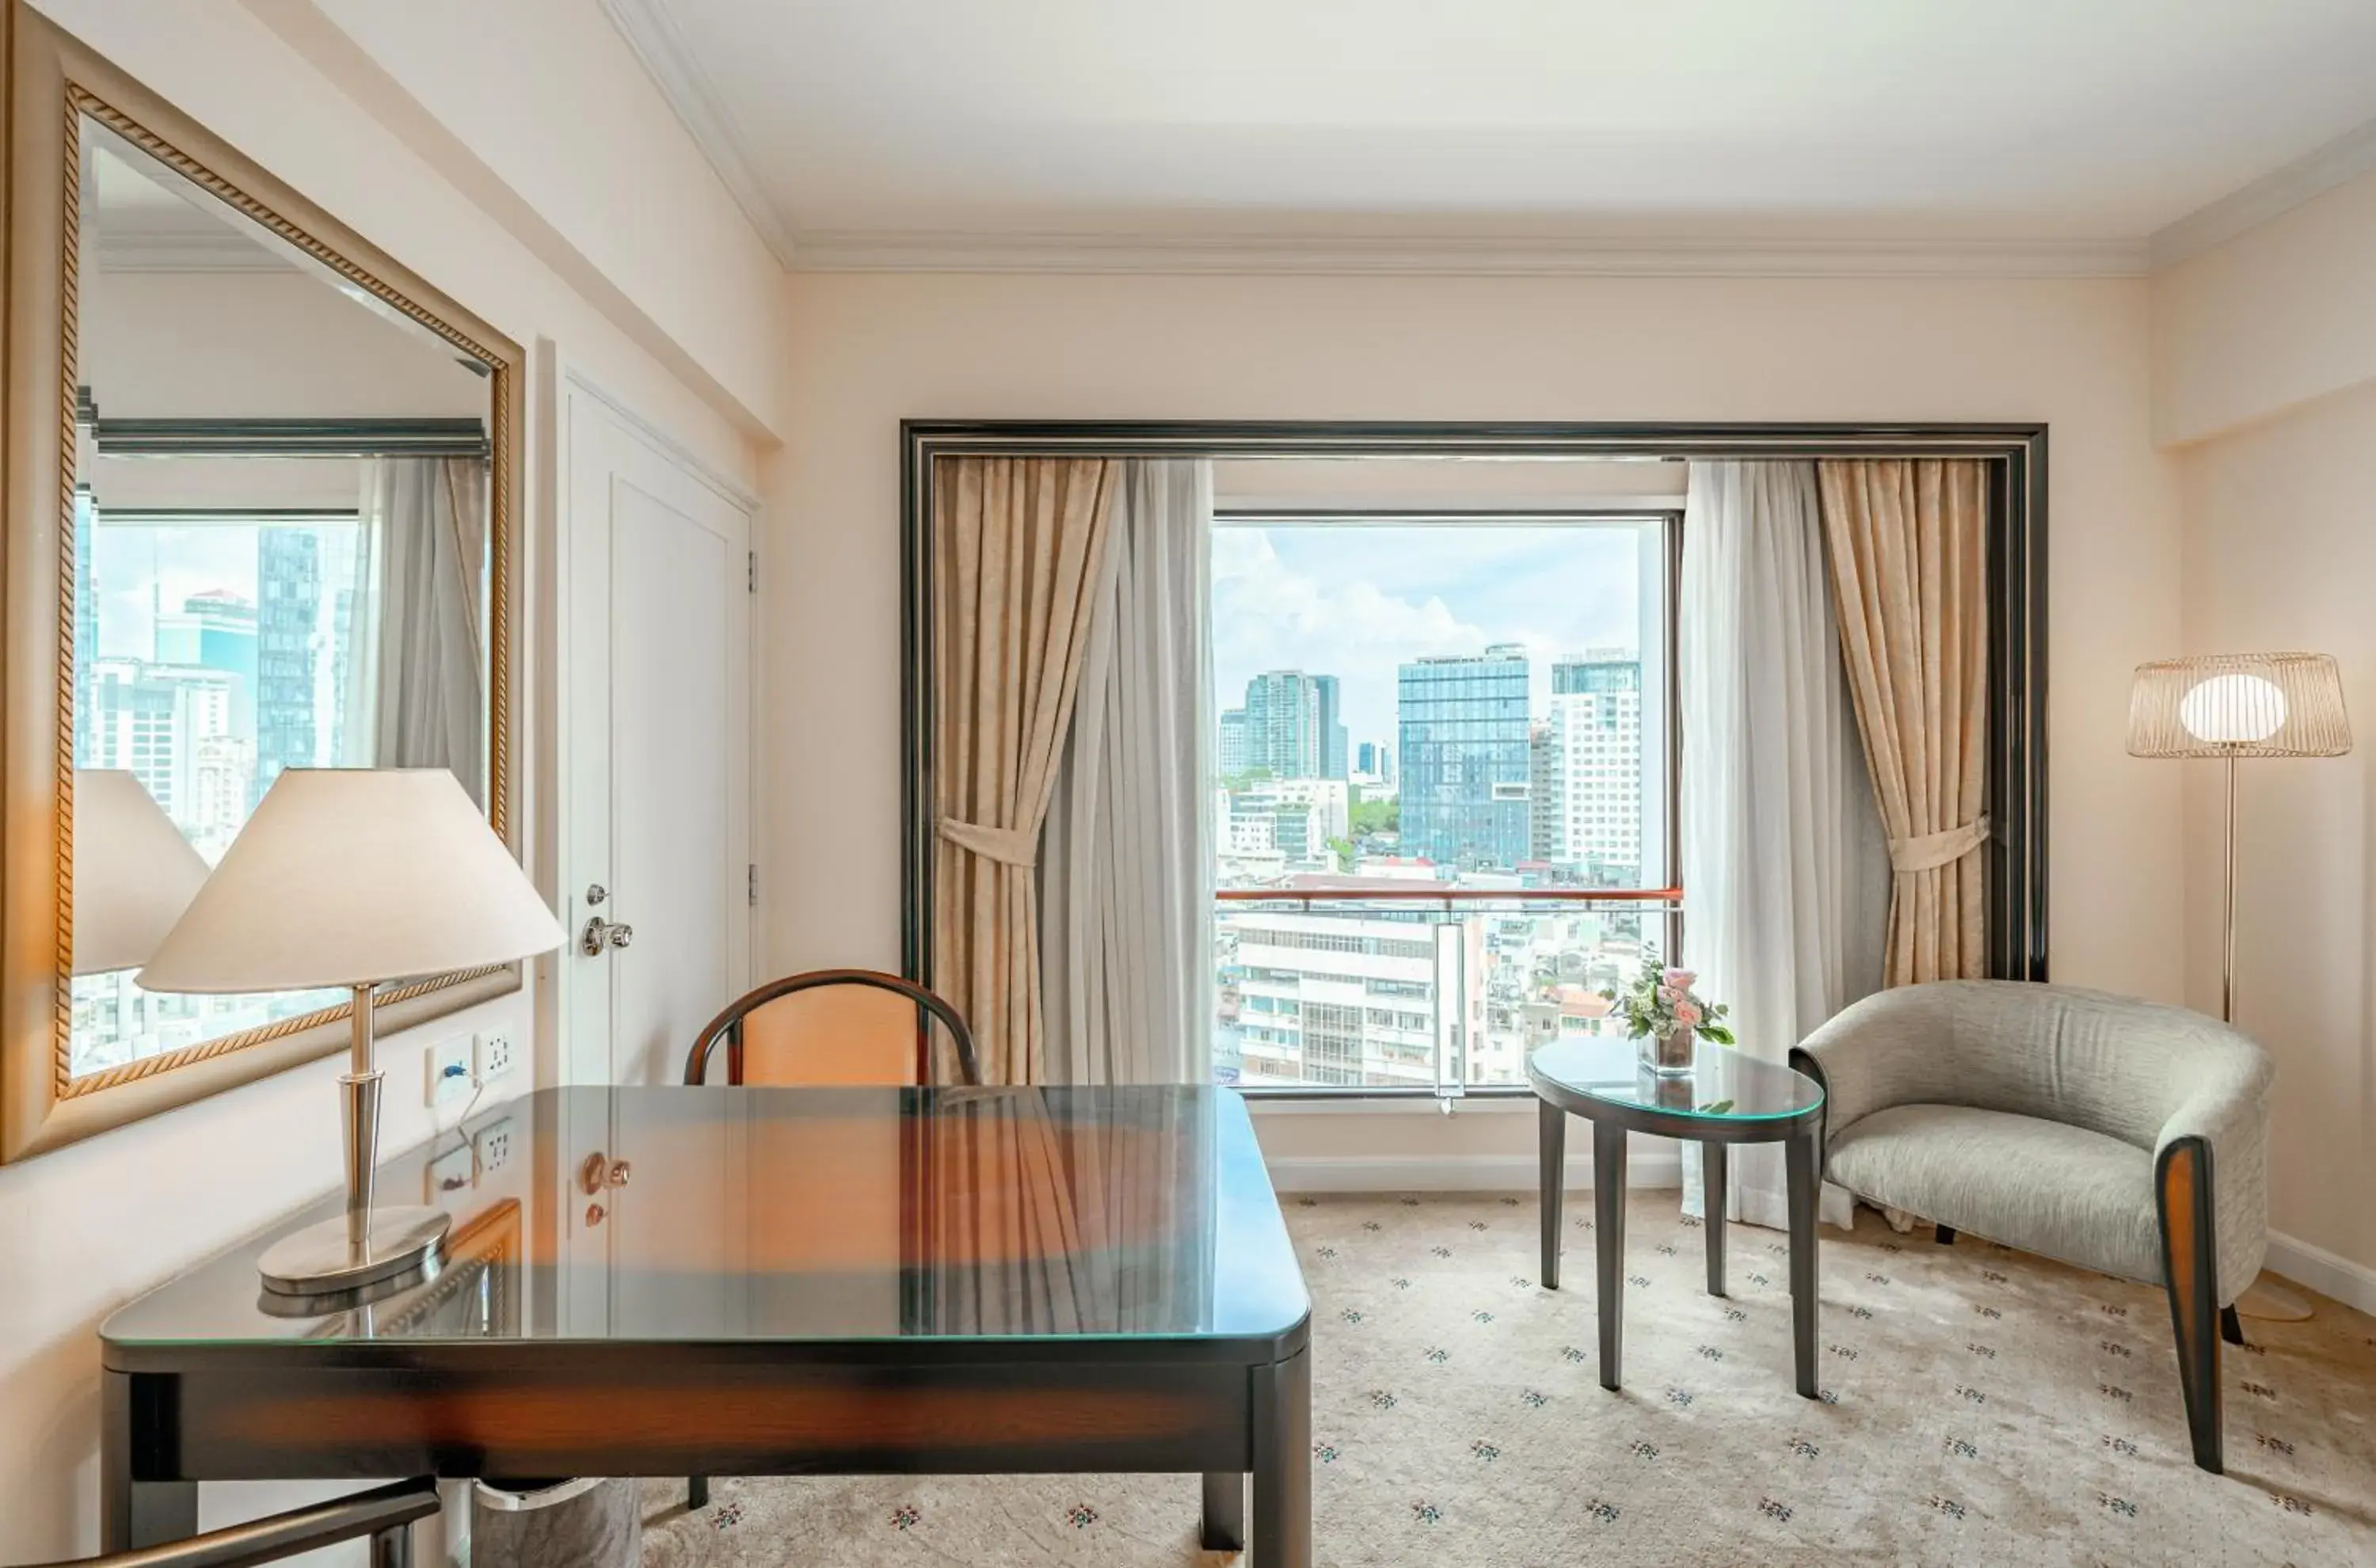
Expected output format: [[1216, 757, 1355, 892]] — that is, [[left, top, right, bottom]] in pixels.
[[2129, 653, 2352, 1321]]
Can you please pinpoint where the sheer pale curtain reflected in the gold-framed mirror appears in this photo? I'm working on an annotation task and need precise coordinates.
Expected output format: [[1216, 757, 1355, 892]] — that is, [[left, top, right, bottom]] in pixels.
[[340, 456, 487, 803]]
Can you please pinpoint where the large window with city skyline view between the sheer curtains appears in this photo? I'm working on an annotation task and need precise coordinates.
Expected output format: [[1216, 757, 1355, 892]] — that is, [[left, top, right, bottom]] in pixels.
[[1212, 516, 1677, 1093]]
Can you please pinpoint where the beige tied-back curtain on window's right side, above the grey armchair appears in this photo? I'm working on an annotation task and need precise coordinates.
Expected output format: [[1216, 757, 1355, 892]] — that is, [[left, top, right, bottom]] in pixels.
[[1818, 459, 1989, 986]]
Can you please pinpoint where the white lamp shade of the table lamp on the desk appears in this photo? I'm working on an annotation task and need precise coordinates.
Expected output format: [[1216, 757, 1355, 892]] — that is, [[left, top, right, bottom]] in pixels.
[[140, 767, 561, 991]]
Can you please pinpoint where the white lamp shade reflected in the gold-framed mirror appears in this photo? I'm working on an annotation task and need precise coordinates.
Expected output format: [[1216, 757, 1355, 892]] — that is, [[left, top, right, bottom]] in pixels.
[[74, 767, 207, 974]]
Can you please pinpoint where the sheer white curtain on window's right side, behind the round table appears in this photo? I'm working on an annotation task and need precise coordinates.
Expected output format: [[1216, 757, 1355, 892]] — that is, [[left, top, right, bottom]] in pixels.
[[1677, 463, 1889, 1228]]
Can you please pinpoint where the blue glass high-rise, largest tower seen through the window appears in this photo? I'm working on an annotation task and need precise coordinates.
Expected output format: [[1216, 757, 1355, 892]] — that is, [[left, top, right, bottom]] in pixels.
[[1395, 644, 1533, 867]]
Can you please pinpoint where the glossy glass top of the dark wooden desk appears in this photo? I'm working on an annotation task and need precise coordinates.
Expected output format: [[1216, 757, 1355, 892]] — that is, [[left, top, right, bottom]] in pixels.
[[100, 1086, 1309, 1352]]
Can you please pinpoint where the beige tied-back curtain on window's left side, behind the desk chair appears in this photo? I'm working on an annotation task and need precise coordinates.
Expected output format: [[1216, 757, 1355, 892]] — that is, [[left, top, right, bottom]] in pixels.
[[931, 459, 1121, 1083]]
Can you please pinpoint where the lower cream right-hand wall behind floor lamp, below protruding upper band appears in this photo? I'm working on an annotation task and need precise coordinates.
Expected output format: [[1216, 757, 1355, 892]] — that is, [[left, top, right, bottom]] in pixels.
[[2176, 382, 2376, 1304]]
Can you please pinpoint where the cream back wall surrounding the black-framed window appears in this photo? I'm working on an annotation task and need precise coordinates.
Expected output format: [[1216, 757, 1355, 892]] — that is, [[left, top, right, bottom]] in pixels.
[[763, 276, 2184, 1159]]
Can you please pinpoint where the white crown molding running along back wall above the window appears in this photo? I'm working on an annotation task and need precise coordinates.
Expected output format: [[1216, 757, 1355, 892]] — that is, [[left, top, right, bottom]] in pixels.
[[786, 230, 2148, 278]]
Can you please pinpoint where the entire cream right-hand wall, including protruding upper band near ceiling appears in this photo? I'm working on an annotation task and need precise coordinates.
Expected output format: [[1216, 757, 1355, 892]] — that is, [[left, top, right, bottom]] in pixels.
[[2153, 159, 2376, 1309]]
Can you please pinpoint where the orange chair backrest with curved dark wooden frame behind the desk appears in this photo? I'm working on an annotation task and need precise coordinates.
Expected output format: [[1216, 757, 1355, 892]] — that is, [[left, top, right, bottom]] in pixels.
[[684, 969, 981, 1083]]
